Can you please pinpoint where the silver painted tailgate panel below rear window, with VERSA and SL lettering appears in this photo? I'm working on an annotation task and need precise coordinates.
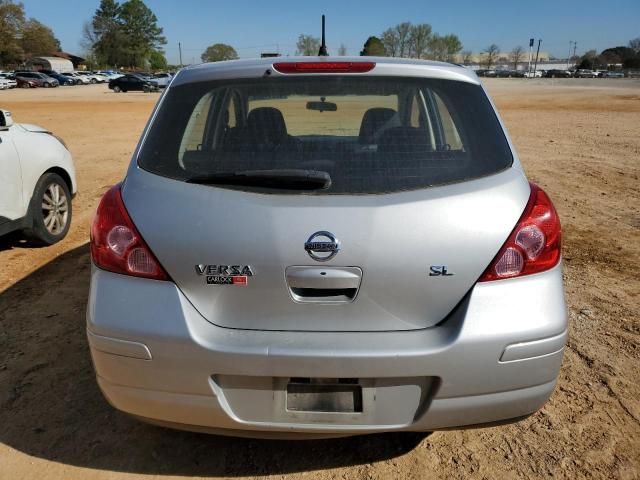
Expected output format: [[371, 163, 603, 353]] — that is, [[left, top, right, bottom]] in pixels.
[[123, 169, 529, 331]]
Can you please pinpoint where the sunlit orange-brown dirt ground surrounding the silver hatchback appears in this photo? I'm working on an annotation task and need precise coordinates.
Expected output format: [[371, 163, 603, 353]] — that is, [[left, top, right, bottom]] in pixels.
[[0, 79, 640, 480]]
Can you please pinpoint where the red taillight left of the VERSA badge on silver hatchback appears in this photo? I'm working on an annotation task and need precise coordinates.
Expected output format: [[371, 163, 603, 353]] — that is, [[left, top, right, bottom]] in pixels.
[[91, 184, 169, 280]]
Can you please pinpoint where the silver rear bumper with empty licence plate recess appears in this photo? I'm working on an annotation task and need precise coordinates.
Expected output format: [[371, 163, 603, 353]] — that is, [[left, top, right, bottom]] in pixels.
[[87, 266, 567, 435]]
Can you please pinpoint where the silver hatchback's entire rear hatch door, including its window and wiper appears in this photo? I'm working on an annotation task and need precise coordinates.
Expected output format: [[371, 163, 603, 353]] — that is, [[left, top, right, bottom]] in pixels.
[[123, 71, 529, 331]]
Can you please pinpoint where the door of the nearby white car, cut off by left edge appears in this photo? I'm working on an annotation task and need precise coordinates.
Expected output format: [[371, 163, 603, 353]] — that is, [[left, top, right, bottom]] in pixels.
[[0, 126, 26, 225]]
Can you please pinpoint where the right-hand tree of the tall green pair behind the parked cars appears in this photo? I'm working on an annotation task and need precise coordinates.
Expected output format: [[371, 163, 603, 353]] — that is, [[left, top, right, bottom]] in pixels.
[[119, 0, 167, 67]]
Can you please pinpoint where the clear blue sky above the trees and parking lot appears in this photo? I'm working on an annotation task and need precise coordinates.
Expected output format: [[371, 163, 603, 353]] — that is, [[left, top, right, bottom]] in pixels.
[[21, 0, 640, 64]]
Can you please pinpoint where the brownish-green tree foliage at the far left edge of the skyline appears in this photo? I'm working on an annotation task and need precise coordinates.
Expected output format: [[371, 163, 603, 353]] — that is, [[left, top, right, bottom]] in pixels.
[[0, 0, 60, 66]]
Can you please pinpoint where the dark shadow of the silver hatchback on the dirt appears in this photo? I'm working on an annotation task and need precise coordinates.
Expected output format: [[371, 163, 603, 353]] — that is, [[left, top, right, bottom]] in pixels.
[[0, 245, 424, 476]]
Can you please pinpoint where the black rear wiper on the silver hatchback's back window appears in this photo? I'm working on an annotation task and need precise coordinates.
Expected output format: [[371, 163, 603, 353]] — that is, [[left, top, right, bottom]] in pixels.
[[186, 169, 331, 190]]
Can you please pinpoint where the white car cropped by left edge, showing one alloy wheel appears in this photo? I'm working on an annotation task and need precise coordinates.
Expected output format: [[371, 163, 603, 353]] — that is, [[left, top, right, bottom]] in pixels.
[[0, 109, 77, 245]]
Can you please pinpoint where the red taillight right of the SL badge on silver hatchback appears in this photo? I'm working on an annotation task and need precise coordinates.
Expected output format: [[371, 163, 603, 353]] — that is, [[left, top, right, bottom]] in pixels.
[[479, 183, 562, 282]]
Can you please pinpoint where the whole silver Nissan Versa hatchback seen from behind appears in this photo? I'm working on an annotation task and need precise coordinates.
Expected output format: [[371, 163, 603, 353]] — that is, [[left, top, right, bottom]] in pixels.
[[87, 57, 567, 437]]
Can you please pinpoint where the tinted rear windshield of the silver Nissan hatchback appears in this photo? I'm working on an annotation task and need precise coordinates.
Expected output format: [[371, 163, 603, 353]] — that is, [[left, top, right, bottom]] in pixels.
[[138, 75, 512, 194]]
